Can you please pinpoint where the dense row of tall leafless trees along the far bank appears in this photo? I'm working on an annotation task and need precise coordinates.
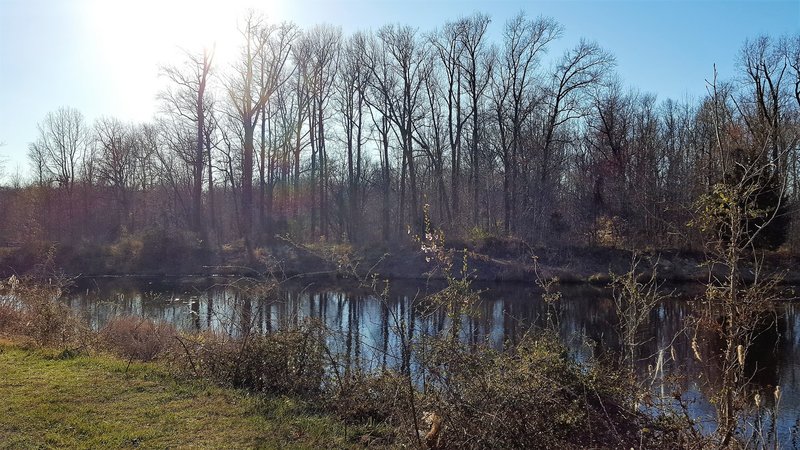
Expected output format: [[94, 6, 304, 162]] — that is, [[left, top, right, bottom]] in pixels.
[[0, 13, 800, 260]]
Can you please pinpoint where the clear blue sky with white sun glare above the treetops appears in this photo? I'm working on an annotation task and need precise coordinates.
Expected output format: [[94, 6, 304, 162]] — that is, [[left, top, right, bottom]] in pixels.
[[0, 0, 800, 173]]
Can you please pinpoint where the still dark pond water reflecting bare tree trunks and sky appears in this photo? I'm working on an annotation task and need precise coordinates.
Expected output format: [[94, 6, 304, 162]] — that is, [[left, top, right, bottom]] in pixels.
[[65, 279, 800, 448]]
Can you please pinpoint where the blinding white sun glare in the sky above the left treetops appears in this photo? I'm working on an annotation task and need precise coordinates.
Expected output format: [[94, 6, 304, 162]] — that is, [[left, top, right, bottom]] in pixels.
[[80, 0, 278, 120]]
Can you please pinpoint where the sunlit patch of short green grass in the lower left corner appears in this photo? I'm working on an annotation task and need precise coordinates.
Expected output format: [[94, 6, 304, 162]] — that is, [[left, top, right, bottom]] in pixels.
[[0, 341, 372, 448]]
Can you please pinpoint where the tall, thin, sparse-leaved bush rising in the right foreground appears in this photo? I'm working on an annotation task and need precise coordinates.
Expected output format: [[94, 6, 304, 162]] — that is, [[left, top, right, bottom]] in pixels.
[[690, 74, 788, 448]]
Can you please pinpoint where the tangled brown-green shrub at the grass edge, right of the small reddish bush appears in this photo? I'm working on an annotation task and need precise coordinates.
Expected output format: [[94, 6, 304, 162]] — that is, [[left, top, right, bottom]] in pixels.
[[176, 322, 326, 395]]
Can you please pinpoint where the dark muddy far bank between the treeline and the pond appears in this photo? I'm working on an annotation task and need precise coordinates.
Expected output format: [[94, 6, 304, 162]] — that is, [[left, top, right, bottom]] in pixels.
[[39, 246, 800, 285]]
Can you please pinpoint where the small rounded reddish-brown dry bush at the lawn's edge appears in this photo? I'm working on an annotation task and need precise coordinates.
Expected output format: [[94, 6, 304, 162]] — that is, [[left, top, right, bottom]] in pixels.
[[100, 316, 176, 361]]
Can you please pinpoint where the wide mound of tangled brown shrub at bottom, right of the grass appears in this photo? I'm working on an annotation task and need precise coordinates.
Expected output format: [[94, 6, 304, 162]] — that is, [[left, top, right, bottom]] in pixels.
[[422, 336, 664, 448]]
